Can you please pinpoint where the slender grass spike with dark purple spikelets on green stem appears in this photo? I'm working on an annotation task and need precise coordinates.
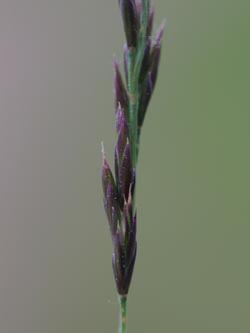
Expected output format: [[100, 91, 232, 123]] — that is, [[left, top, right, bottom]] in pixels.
[[102, 0, 164, 333]]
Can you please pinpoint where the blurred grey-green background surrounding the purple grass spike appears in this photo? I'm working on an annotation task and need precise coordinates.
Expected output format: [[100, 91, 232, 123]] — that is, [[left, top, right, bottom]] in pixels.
[[0, 0, 250, 333]]
